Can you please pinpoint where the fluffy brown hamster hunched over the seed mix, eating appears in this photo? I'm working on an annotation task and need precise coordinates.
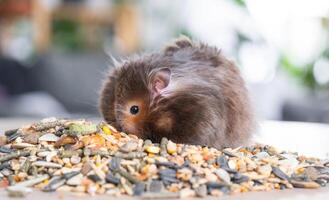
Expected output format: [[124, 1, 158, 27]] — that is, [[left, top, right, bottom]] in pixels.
[[100, 37, 254, 148]]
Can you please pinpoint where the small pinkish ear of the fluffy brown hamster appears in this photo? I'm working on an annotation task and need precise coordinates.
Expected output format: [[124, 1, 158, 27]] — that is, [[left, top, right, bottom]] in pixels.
[[149, 68, 171, 99]]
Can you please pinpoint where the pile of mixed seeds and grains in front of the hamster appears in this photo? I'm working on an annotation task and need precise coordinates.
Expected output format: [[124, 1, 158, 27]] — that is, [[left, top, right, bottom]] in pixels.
[[0, 118, 329, 198]]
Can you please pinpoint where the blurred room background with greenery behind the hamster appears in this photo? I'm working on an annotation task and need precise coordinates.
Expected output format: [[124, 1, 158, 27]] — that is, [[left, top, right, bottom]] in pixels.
[[0, 0, 329, 123]]
